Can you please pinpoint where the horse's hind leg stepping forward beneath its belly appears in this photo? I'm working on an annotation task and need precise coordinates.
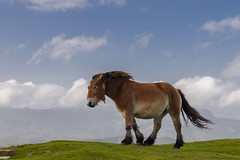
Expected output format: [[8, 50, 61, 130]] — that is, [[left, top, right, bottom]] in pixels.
[[144, 110, 167, 146]]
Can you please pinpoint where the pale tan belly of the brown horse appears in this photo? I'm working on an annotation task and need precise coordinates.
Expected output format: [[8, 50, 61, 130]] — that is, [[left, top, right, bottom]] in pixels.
[[133, 101, 168, 119]]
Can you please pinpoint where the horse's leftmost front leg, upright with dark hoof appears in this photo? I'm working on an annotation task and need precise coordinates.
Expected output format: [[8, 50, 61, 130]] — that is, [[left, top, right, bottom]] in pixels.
[[122, 112, 133, 145]]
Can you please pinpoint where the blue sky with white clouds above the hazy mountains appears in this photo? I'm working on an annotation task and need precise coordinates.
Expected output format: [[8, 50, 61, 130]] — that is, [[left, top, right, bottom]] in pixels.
[[0, 0, 240, 119]]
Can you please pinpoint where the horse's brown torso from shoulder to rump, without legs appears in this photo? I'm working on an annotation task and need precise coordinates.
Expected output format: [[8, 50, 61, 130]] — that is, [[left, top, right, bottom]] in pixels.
[[119, 81, 180, 118]]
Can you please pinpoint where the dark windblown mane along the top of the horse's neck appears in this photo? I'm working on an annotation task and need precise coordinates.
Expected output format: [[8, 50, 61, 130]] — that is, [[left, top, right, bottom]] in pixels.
[[92, 71, 133, 81]]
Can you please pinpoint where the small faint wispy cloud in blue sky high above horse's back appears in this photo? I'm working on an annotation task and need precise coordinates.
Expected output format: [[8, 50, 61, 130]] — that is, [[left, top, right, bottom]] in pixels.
[[129, 32, 154, 51]]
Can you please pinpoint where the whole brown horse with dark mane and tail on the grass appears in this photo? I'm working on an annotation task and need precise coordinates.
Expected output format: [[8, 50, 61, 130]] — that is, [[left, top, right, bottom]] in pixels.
[[87, 71, 212, 149]]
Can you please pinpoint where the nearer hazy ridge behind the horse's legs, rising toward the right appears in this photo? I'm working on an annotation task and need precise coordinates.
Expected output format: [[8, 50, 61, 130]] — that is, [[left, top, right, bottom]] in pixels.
[[87, 110, 240, 144]]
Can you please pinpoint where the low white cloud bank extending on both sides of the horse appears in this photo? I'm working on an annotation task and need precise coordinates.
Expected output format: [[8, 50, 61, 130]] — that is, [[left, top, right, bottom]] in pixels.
[[0, 76, 240, 109]]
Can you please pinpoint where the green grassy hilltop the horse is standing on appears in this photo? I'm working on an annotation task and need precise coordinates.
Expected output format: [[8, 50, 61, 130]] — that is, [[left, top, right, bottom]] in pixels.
[[2, 139, 240, 160]]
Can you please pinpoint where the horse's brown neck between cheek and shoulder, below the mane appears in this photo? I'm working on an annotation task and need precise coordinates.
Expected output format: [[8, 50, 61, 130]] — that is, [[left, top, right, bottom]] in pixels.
[[105, 80, 126, 101]]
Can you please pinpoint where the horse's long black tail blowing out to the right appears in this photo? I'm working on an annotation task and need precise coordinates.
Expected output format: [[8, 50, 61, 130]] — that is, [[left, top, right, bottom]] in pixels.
[[178, 89, 212, 129]]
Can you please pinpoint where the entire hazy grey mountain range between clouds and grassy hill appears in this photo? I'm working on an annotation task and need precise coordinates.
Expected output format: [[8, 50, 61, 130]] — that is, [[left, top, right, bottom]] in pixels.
[[0, 107, 240, 147]]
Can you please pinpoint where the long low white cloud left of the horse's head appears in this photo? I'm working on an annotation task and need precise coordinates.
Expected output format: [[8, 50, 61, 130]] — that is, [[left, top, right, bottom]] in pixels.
[[0, 79, 87, 109]]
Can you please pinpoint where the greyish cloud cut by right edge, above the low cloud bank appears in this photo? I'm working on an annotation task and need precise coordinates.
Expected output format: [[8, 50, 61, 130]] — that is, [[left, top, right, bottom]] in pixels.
[[222, 54, 240, 78]]
